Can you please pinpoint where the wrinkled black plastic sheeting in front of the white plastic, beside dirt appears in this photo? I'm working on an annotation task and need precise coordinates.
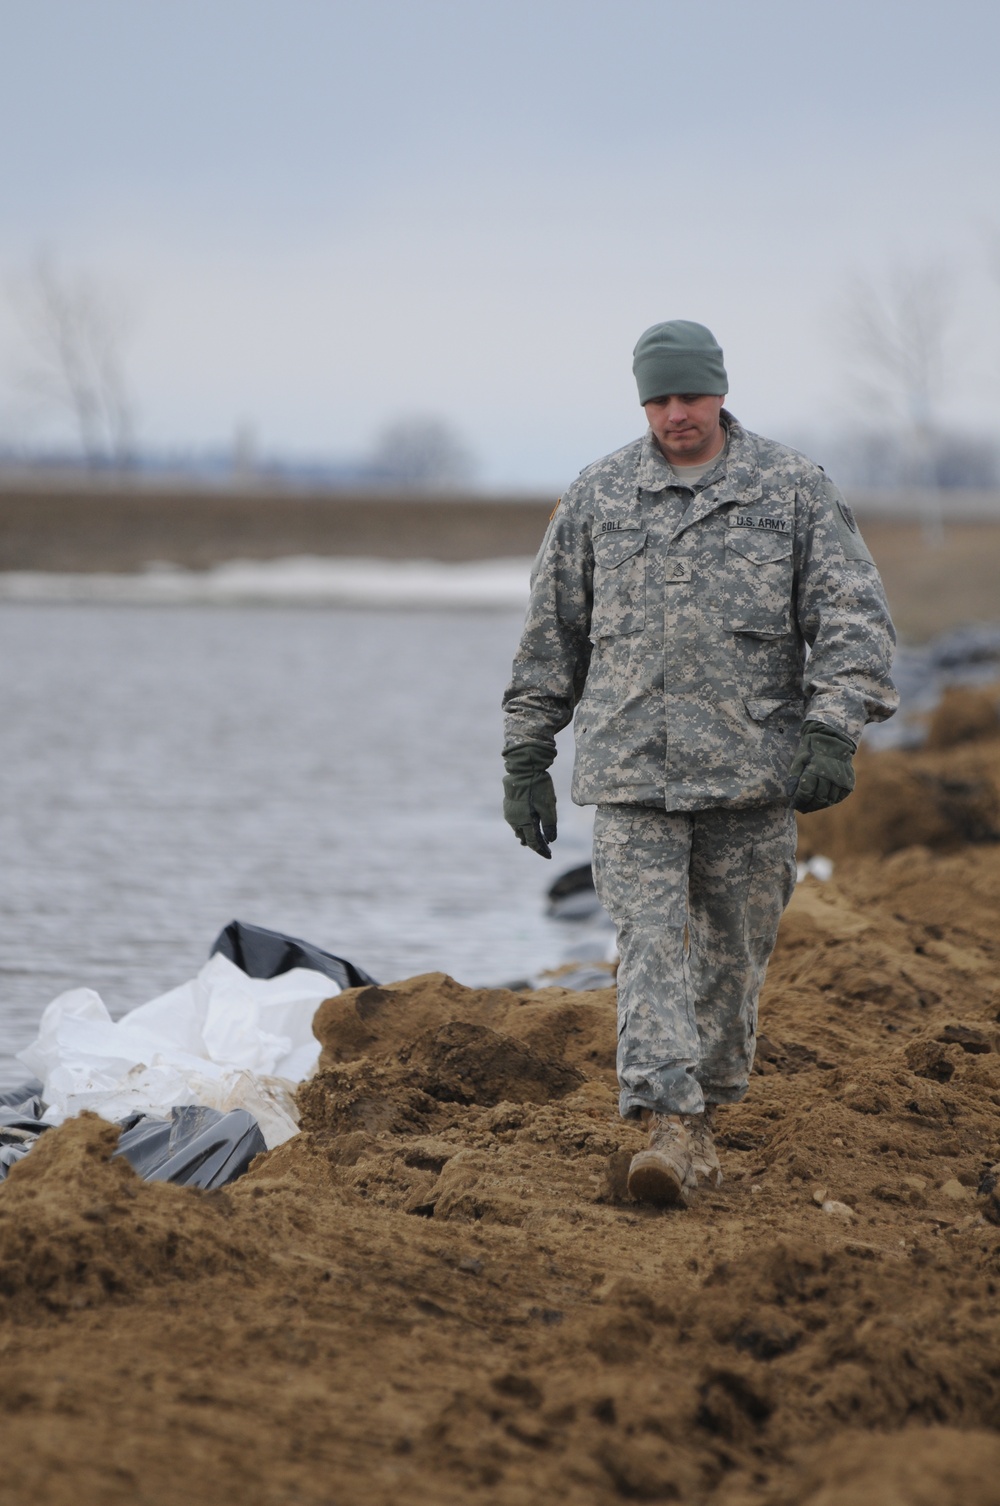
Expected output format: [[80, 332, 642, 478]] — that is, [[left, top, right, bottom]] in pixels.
[[0, 1083, 267, 1191]]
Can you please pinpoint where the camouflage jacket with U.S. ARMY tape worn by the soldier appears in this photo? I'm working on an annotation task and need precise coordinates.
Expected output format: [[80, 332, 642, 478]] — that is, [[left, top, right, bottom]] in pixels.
[[503, 411, 899, 810]]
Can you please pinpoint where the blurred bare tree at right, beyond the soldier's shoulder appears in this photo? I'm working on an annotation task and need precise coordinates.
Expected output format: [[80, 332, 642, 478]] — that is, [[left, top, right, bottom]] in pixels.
[[843, 265, 952, 542]]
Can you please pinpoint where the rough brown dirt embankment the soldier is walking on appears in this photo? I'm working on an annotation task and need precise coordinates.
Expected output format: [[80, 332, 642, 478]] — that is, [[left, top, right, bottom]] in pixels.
[[0, 689, 1000, 1506]]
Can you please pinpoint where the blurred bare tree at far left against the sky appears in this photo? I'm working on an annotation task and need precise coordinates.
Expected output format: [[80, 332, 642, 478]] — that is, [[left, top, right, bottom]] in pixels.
[[12, 253, 134, 465]]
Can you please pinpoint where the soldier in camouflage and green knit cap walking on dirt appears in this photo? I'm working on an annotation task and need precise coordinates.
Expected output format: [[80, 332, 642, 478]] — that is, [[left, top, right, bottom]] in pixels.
[[503, 319, 899, 1206]]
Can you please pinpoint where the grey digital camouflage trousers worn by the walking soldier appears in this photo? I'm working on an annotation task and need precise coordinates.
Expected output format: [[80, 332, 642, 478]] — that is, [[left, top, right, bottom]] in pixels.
[[593, 804, 795, 1117]]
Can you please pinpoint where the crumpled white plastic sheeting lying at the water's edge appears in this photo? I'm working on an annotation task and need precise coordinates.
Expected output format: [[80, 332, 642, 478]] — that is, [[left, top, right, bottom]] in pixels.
[[18, 955, 340, 1149]]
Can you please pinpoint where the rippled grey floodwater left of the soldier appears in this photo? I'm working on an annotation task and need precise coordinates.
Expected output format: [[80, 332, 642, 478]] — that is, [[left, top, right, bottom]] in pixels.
[[0, 604, 590, 1078]]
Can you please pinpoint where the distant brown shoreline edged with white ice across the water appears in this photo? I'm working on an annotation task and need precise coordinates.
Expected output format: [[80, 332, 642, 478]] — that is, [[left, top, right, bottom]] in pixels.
[[0, 480, 1000, 643]]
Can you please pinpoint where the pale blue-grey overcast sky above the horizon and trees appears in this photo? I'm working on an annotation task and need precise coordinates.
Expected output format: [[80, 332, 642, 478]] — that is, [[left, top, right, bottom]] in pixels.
[[0, 0, 1000, 489]]
